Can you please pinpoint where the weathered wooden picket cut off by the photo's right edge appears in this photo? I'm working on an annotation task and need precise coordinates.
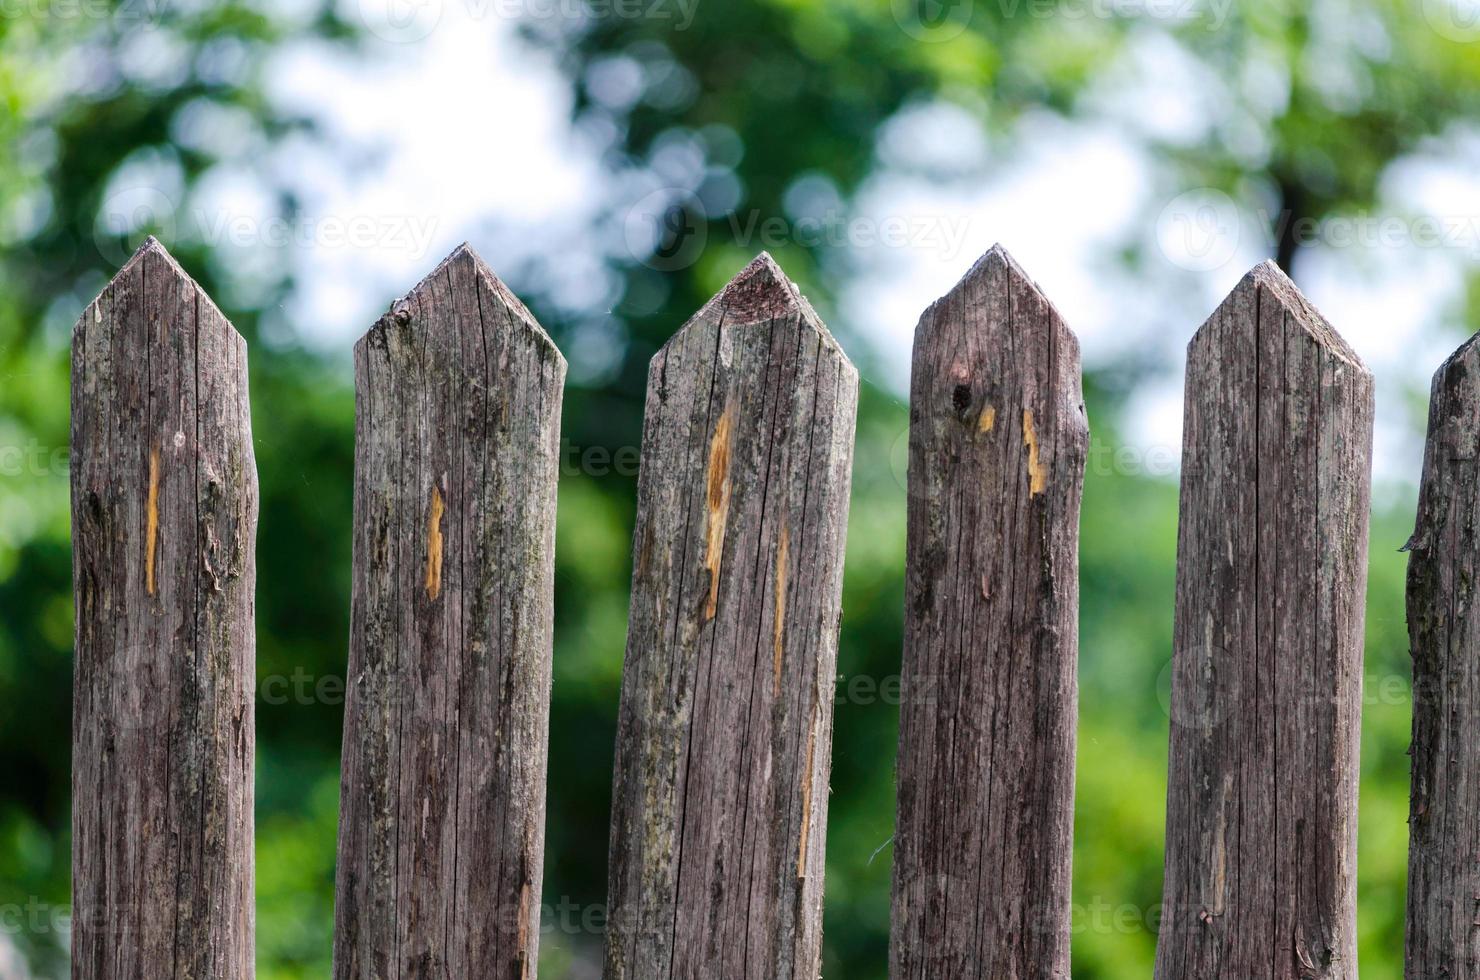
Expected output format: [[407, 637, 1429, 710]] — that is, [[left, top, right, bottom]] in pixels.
[[1406, 338, 1480, 980]]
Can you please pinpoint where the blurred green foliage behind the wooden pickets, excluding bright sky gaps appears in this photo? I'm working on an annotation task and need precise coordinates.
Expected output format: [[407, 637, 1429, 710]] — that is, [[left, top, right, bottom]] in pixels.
[[0, 0, 1480, 980]]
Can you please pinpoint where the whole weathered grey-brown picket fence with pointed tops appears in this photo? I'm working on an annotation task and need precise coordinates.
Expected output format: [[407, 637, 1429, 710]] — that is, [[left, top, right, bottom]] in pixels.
[[73, 233, 1480, 980]]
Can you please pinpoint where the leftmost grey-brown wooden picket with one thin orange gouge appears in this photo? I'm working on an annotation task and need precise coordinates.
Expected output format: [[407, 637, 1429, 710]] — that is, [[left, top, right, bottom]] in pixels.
[[71, 238, 258, 980]]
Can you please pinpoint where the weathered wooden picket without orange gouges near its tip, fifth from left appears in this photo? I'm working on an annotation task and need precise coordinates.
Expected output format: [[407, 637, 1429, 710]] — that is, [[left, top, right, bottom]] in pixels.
[[1156, 262, 1373, 980]]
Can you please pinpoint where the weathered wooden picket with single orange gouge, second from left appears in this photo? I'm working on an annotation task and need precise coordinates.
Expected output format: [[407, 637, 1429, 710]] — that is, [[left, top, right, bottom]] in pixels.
[[334, 246, 565, 980]]
